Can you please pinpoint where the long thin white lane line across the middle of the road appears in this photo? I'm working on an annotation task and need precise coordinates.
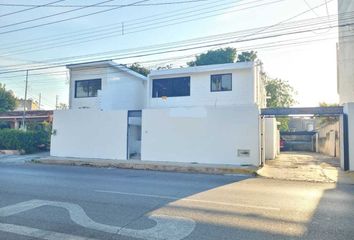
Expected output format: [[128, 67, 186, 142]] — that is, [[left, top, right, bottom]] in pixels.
[[95, 190, 280, 211]]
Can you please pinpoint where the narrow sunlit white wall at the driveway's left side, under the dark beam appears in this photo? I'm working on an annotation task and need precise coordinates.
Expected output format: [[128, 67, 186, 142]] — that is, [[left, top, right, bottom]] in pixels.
[[264, 118, 279, 160]]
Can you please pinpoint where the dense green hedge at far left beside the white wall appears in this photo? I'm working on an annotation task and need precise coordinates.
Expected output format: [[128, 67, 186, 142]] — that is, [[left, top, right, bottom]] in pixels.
[[0, 126, 50, 153]]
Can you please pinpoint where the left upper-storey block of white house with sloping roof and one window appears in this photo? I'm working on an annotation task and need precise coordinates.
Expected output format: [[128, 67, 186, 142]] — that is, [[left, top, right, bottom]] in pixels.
[[67, 61, 147, 110]]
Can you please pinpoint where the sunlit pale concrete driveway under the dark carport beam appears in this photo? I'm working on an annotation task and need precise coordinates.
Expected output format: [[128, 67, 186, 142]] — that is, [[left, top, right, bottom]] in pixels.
[[258, 152, 340, 182]]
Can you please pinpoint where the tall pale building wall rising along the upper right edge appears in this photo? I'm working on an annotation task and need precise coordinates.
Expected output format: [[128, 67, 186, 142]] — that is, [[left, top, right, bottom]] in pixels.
[[338, 0, 354, 104]]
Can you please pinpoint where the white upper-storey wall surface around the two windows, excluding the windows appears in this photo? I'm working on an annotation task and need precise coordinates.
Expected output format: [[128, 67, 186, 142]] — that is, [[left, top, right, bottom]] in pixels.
[[147, 64, 260, 108]]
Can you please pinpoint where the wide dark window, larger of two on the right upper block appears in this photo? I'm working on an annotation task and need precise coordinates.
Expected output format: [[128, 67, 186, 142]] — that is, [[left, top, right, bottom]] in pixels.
[[152, 77, 191, 98]]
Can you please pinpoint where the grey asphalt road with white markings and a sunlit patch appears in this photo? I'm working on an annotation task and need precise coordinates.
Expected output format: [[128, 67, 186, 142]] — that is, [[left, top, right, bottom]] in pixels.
[[0, 163, 354, 240]]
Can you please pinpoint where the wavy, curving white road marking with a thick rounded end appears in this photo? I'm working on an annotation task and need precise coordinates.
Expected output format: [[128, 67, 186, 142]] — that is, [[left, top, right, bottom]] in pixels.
[[0, 200, 195, 240]]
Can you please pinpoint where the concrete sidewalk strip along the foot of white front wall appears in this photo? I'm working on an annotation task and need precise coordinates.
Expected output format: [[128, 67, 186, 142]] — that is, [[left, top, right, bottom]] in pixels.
[[32, 157, 258, 175]]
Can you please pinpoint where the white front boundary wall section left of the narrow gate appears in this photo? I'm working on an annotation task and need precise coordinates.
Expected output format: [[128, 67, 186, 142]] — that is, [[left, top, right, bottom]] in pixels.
[[50, 109, 127, 159]]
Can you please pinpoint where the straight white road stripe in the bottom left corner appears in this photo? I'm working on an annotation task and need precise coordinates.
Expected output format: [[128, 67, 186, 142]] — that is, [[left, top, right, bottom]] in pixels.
[[0, 223, 95, 240]]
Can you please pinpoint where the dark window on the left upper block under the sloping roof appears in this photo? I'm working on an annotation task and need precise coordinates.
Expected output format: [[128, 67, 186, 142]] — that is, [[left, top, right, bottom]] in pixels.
[[75, 79, 102, 98]]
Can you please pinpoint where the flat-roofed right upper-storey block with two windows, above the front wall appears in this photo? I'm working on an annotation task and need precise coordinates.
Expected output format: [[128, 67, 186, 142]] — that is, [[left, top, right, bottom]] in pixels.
[[147, 62, 265, 108]]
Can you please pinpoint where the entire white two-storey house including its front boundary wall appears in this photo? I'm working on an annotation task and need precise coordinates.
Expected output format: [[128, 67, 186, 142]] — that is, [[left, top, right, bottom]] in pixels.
[[51, 61, 276, 165]]
